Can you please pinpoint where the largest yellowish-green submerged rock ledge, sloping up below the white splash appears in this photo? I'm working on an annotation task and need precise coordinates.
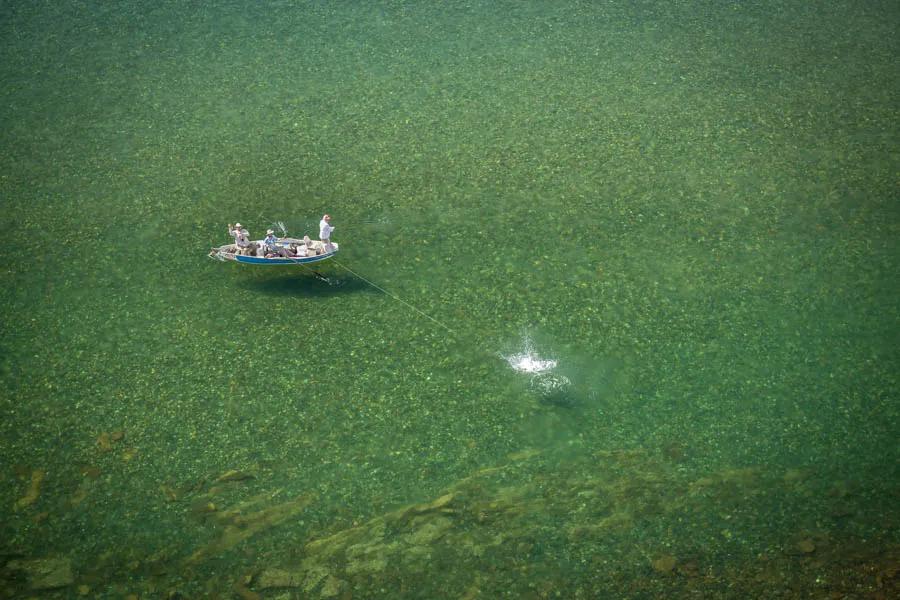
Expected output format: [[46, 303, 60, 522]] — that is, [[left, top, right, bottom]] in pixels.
[[248, 449, 844, 597]]
